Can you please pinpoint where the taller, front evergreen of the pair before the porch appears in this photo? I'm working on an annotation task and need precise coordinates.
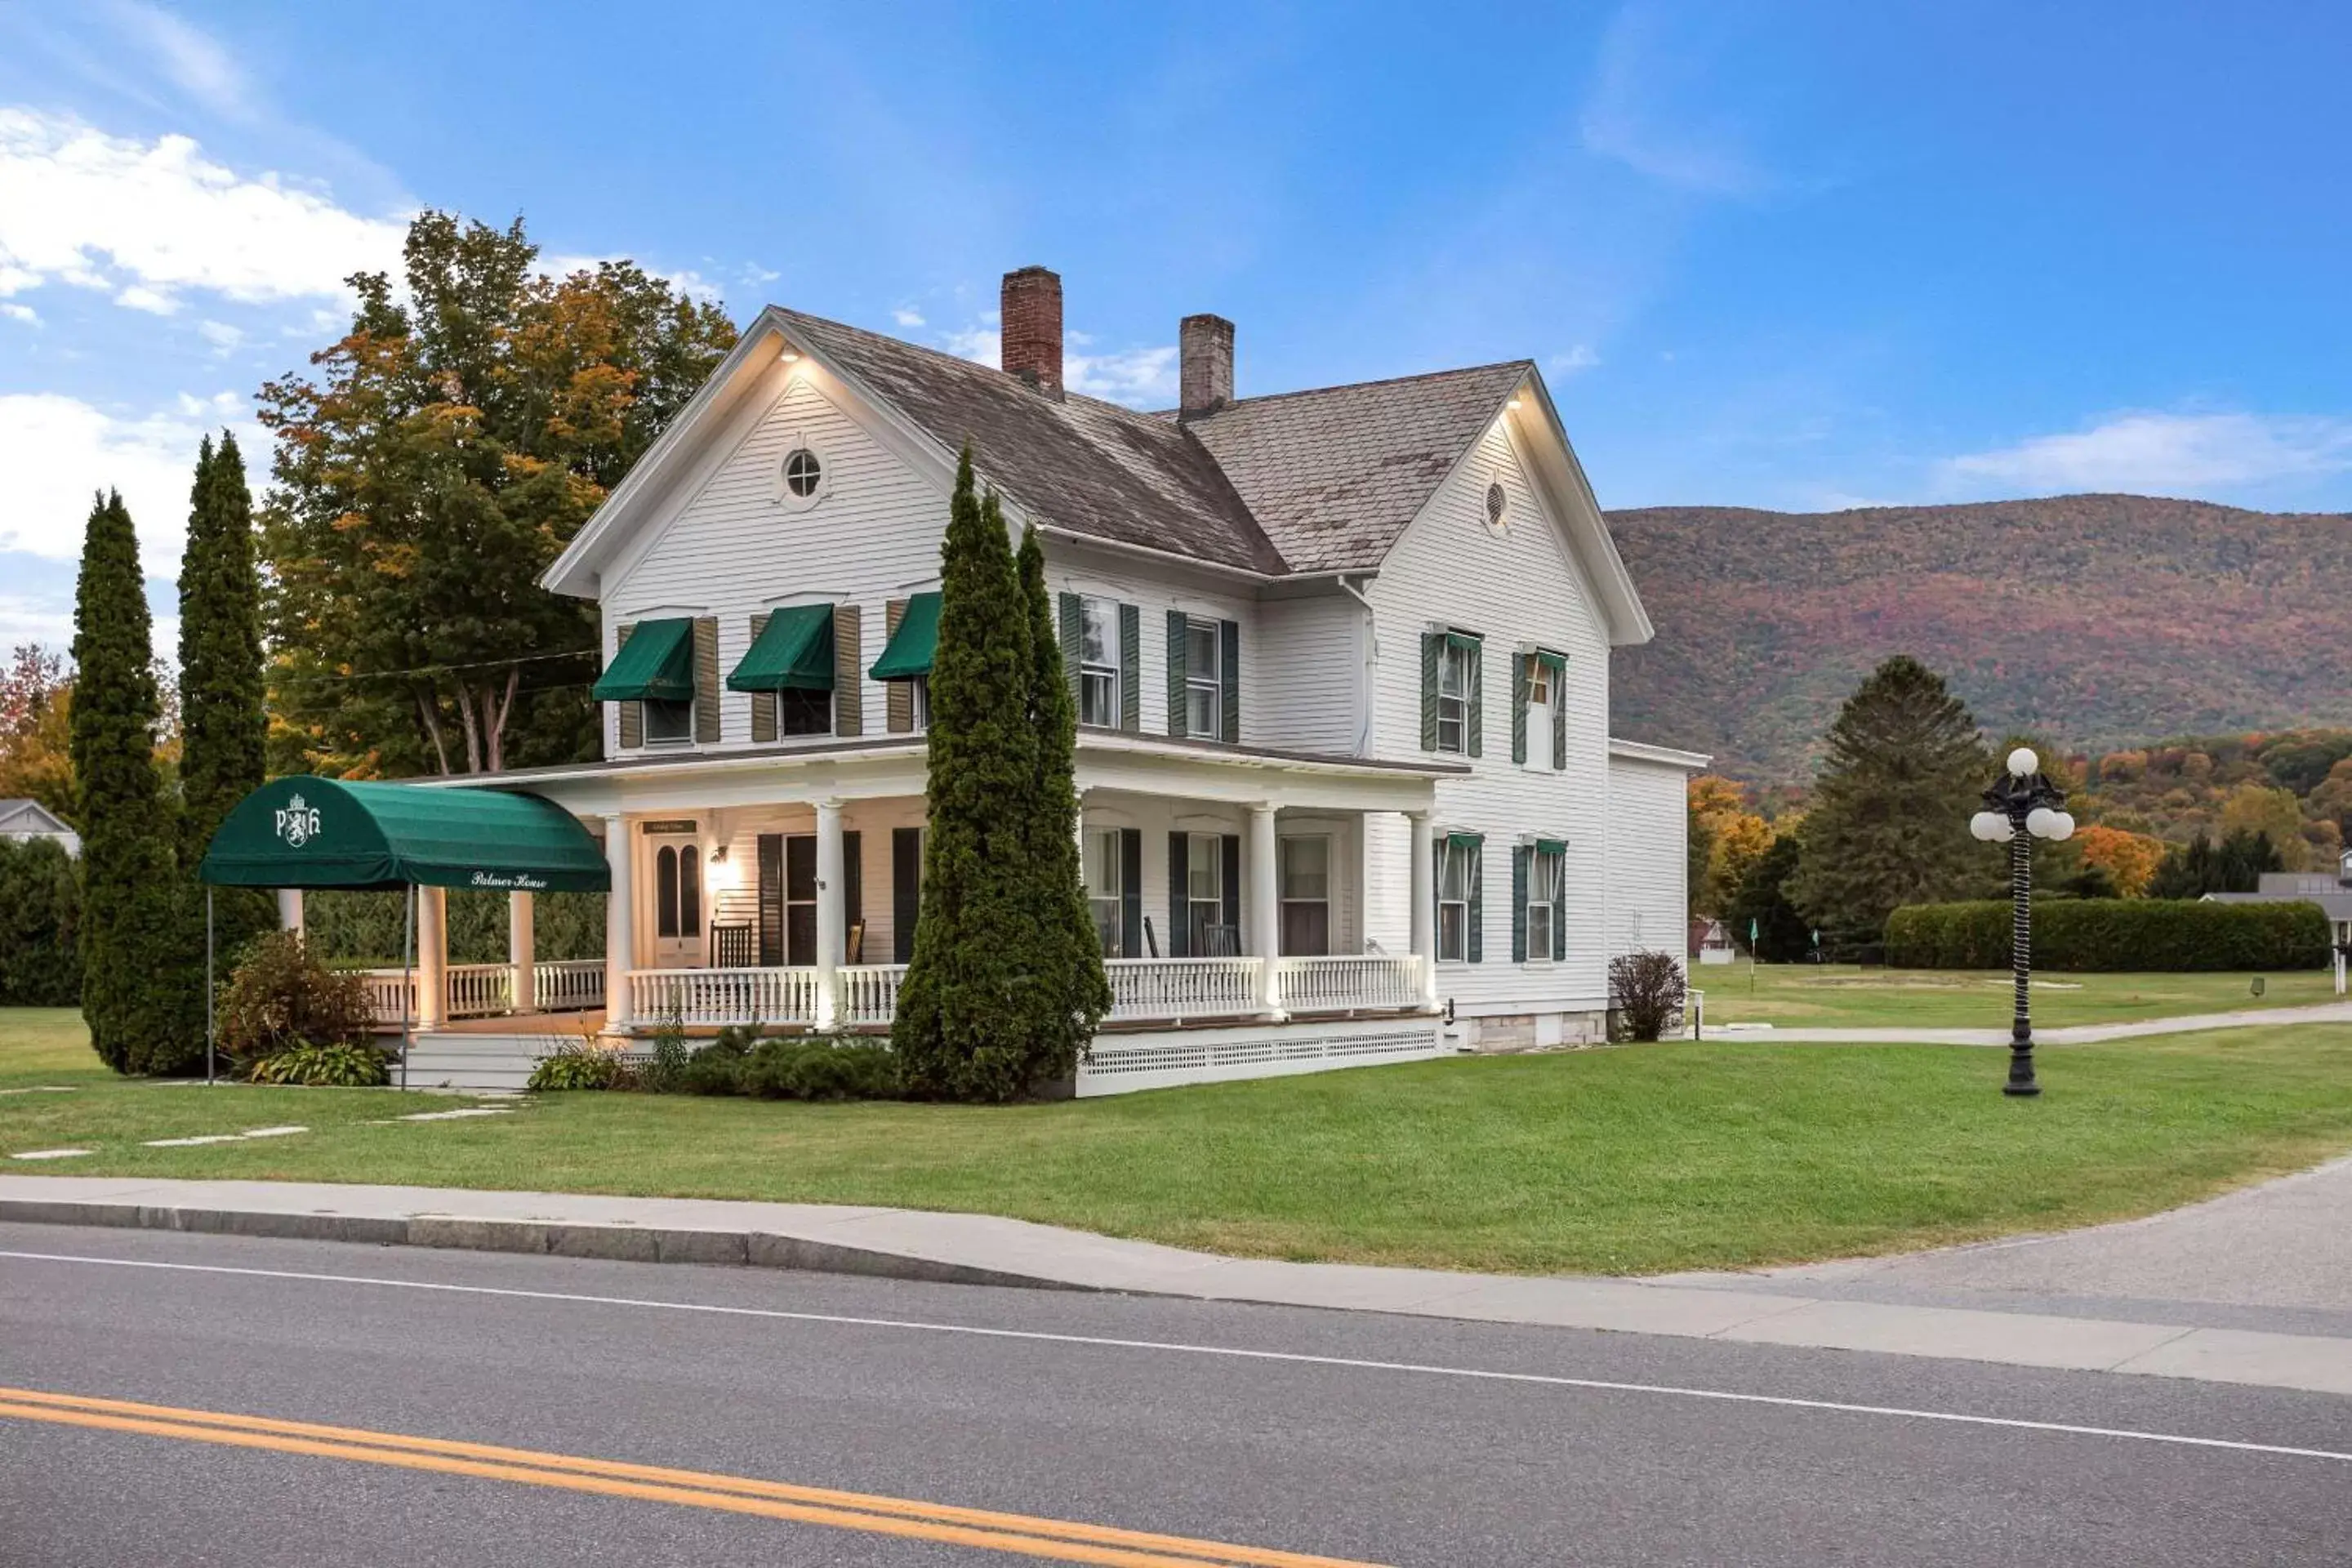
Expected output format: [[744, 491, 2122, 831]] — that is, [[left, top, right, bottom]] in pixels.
[[892, 447, 1058, 1100]]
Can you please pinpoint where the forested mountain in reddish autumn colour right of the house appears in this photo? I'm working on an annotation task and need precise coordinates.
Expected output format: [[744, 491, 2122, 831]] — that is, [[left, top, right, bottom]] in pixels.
[[1609, 496, 2352, 783]]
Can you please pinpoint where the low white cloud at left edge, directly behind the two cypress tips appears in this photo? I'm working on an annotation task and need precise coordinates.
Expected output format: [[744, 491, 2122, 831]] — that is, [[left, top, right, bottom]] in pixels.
[[0, 393, 268, 576]]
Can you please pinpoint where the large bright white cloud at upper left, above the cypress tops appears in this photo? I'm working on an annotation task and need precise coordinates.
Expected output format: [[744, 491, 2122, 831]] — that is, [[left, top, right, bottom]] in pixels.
[[0, 108, 407, 310]]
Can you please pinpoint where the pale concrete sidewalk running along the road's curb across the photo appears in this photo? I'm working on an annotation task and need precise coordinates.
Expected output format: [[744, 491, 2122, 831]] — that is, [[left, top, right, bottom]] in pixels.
[[0, 1175, 2352, 1394]]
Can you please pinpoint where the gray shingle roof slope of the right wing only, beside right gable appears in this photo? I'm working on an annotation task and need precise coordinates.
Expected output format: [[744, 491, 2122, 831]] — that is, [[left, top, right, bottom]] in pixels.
[[1186, 359, 1534, 571]]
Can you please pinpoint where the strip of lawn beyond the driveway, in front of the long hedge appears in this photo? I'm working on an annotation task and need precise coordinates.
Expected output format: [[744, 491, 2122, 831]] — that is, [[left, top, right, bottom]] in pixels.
[[1691, 959, 2336, 1030]]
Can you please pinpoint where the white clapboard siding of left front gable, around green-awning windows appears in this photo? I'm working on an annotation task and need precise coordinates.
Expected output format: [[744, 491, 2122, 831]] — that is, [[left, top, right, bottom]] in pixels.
[[604, 376, 948, 755]]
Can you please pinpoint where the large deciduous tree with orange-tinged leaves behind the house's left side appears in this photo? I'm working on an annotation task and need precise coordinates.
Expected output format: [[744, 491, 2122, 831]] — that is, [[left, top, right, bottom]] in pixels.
[[261, 212, 734, 773]]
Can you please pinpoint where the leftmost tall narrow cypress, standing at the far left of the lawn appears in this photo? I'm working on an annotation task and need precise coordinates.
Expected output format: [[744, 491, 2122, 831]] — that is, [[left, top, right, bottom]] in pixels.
[[73, 493, 205, 1072]]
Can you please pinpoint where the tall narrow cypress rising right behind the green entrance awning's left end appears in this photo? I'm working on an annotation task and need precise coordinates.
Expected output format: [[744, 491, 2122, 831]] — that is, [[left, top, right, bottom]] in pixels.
[[179, 430, 275, 959]]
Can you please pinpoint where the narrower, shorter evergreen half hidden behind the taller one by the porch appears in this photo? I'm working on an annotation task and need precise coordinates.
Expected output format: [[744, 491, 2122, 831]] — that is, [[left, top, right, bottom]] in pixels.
[[1020, 522, 1110, 1079]]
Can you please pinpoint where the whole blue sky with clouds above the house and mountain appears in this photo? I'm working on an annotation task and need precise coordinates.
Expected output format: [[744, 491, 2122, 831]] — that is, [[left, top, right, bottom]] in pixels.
[[0, 0, 2352, 642]]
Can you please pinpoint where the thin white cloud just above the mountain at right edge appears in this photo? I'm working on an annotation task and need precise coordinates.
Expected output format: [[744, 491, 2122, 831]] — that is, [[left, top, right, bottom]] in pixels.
[[1943, 412, 2352, 493]]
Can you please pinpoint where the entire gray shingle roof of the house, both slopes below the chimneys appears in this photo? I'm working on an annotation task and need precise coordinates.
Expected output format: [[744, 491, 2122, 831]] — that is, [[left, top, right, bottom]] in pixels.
[[774, 310, 1531, 576]]
